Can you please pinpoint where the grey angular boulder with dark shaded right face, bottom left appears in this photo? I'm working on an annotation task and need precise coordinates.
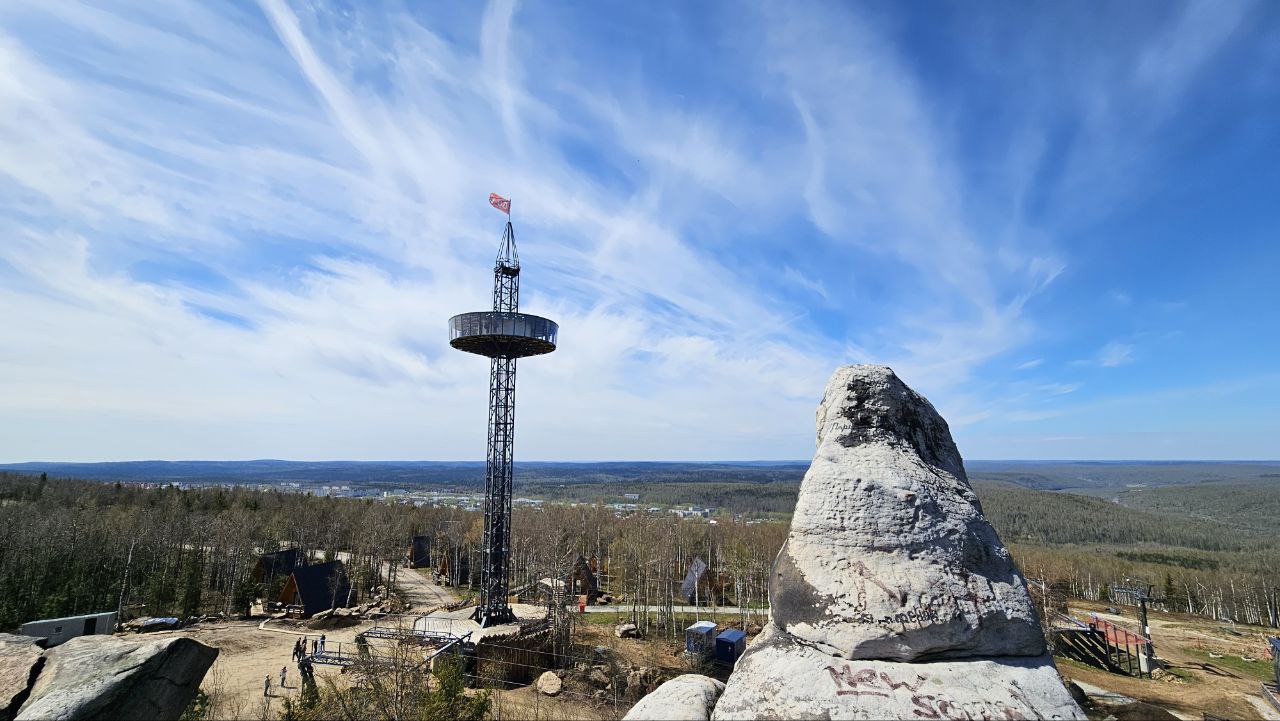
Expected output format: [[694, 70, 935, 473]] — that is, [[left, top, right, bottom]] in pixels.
[[17, 635, 218, 720]]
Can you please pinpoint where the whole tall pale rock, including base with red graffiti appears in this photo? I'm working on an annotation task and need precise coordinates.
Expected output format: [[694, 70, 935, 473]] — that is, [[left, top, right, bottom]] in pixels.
[[628, 365, 1085, 720]]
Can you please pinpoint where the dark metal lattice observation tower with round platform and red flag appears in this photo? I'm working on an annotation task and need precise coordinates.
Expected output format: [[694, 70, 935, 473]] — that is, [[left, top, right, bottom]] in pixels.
[[449, 195, 559, 626]]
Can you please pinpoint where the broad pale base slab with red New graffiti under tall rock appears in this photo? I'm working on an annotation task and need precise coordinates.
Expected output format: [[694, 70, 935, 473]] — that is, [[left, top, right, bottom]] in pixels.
[[716, 626, 1085, 721]]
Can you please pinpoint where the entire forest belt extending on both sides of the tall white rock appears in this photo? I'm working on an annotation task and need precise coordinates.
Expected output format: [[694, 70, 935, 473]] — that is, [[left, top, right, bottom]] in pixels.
[[0, 473, 1280, 633]]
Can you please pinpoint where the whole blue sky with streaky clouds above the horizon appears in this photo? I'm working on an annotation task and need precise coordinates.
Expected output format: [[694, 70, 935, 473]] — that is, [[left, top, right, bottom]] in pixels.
[[0, 0, 1280, 461]]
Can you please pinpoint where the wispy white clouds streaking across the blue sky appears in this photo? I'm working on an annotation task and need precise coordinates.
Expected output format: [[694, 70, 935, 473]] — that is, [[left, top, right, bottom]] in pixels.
[[0, 0, 1264, 460]]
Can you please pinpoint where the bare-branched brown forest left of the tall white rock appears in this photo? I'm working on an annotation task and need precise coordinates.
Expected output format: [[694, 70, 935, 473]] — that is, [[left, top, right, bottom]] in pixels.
[[0, 474, 786, 640]]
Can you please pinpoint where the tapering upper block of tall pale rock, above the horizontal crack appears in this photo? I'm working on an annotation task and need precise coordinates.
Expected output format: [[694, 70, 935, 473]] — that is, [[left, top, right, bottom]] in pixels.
[[769, 365, 1044, 661]]
